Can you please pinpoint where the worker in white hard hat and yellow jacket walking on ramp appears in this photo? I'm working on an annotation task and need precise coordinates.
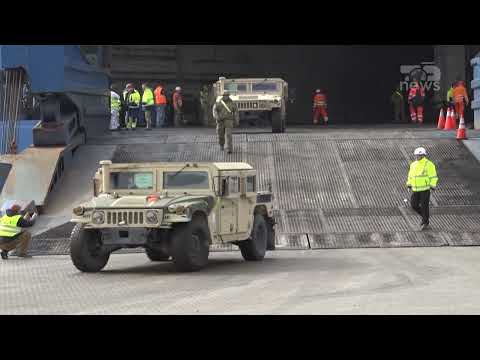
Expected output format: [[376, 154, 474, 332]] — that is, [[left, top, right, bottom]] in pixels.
[[407, 147, 438, 230]]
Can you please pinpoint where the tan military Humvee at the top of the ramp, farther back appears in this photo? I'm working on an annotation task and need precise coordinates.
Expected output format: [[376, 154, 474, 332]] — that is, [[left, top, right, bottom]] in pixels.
[[204, 77, 288, 133]]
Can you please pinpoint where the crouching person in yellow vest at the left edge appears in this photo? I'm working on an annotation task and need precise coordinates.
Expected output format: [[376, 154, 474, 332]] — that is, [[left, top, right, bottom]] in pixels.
[[0, 204, 37, 260]]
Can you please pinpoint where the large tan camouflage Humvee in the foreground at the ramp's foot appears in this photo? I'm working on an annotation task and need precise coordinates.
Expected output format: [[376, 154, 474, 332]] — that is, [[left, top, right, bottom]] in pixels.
[[70, 160, 275, 272]]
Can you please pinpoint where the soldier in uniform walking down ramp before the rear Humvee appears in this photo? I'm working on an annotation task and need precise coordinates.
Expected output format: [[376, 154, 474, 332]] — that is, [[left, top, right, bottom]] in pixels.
[[213, 91, 238, 154]]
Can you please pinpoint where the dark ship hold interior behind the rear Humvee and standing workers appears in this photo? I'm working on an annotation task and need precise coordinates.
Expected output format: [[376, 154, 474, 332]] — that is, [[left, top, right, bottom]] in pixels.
[[111, 45, 434, 125]]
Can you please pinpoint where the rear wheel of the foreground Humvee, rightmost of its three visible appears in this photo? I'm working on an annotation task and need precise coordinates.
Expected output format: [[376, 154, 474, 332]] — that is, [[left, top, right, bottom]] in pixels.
[[238, 214, 268, 261]]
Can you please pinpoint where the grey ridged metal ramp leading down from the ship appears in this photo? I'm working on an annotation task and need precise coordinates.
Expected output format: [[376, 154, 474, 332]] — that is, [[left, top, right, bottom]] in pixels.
[[32, 129, 480, 253]]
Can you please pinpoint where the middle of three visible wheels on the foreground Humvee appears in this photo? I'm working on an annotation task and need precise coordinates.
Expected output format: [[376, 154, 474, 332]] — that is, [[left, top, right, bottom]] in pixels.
[[171, 216, 210, 272]]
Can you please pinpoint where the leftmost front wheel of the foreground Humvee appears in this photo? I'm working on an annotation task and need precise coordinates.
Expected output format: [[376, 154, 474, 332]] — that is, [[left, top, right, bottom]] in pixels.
[[70, 224, 110, 272]]
